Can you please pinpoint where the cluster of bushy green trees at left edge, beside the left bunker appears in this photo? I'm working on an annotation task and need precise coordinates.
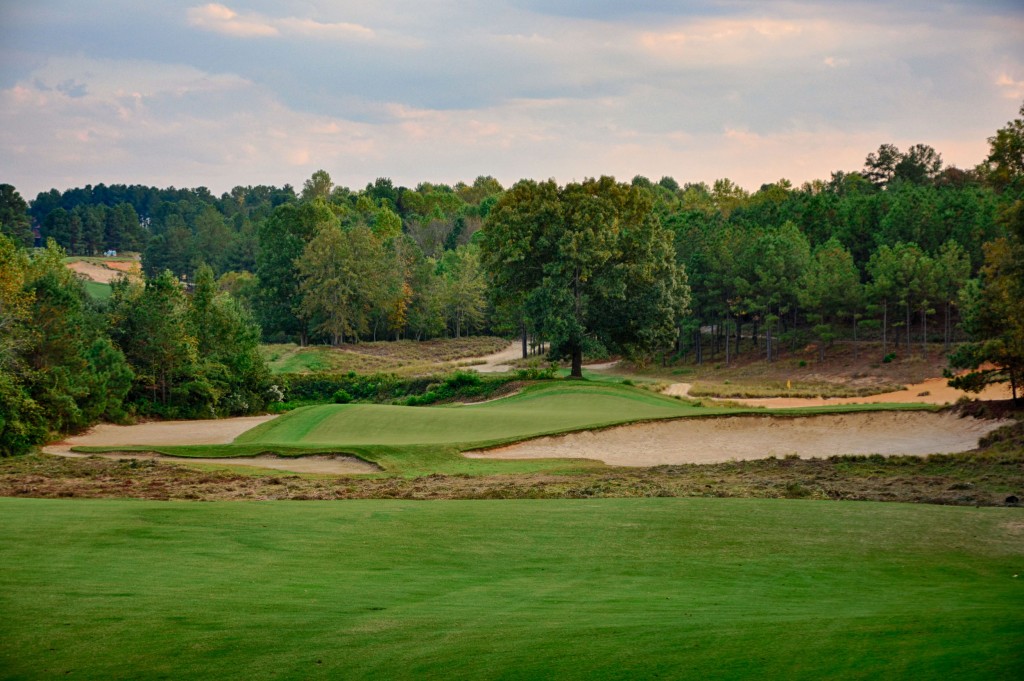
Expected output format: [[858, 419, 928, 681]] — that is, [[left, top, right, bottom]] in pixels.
[[0, 240, 272, 456]]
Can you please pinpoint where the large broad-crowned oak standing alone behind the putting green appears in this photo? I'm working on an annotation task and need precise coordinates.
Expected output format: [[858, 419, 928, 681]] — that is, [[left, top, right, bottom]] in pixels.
[[481, 177, 689, 378]]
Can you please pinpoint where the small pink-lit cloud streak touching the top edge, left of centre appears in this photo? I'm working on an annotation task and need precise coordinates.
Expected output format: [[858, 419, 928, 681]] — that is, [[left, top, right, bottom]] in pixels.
[[186, 3, 375, 40]]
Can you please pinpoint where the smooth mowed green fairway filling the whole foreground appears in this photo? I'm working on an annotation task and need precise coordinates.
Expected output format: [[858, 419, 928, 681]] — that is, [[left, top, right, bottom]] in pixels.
[[0, 499, 1024, 679]]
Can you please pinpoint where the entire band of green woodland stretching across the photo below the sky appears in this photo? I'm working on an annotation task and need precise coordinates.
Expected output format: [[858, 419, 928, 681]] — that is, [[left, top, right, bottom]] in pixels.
[[0, 102, 1024, 450]]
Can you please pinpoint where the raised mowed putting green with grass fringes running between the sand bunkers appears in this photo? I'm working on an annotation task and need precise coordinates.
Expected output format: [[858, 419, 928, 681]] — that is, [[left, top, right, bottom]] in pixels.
[[74, 381, 935, 476]]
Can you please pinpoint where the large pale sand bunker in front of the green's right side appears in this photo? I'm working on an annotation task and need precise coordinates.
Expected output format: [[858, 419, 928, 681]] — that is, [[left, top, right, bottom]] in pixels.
[[465, 411, 1011, 466]]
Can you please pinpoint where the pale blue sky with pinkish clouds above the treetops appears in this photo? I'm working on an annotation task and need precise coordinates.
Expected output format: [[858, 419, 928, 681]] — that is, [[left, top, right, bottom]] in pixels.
[[0, 0, 1024, 200]]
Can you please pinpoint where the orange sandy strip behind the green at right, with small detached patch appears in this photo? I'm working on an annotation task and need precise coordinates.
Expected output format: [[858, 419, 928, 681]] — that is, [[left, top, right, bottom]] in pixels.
[[665, 378, 1011, 409]]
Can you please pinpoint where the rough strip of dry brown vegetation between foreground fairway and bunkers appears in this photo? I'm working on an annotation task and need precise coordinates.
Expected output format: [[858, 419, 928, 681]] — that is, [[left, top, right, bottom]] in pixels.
[[0, 423, 1024, 506]]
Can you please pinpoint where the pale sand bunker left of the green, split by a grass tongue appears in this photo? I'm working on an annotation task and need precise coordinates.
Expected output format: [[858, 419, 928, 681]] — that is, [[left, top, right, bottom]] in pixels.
[[43, 416, 380, 474]]
